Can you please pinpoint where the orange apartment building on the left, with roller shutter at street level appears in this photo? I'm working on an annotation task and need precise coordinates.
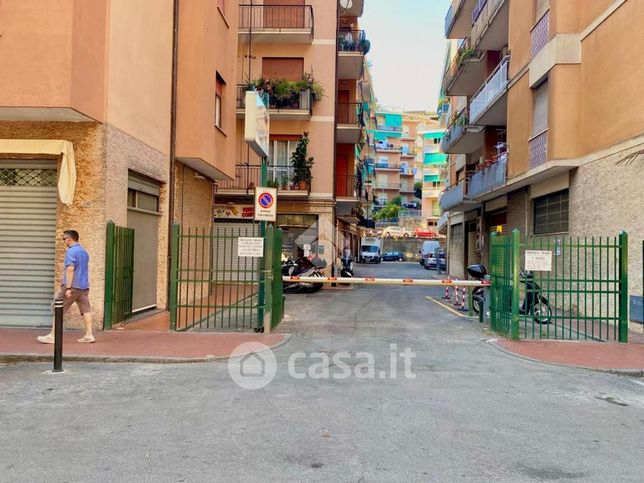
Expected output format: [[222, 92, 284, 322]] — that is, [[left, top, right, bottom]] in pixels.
[[0, 0, 238, 327]]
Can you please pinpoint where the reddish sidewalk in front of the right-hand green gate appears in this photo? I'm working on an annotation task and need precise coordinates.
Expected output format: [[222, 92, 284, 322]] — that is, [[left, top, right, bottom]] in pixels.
[[490, 339, 644, 377]]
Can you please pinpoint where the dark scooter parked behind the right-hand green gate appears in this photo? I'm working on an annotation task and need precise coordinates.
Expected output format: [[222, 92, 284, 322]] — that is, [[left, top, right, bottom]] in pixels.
[[467, 264, 552, 324]]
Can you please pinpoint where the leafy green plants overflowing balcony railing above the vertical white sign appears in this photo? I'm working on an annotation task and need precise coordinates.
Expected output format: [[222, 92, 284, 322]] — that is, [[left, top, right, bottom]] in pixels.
[[244, 72, 324, 109]]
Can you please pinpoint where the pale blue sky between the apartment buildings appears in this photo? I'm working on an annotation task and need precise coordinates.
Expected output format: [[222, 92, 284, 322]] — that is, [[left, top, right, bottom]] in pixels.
[[358, 0, 451, 111]]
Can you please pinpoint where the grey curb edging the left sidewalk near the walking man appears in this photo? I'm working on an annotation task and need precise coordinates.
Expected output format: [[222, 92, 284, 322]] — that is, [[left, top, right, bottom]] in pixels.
[[0, 334, 291, 364]]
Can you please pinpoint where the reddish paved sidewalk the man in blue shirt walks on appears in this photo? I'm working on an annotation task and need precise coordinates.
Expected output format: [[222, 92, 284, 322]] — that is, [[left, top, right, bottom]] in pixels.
[[0, 329, 289, 363]]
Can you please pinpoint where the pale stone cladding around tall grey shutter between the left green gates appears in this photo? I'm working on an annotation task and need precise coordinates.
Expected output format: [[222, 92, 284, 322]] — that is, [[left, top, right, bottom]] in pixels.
[[105, 124, 170, 308]]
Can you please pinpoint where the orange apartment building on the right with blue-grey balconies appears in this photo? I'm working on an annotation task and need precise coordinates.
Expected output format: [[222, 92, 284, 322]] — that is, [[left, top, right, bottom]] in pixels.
[[440, 0, 644, 304]]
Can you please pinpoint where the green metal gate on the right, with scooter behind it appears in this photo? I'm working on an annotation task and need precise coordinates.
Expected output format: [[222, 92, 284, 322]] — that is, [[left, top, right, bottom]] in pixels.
[[490, 230, 628, 342]]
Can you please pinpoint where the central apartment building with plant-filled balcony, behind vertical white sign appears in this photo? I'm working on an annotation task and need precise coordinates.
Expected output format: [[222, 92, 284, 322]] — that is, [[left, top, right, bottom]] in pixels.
[[215, 0, 366, 266]]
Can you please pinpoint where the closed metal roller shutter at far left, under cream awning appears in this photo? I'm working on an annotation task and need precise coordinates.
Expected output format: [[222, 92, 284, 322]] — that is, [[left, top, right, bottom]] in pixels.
[[0, 161, 57, 327]]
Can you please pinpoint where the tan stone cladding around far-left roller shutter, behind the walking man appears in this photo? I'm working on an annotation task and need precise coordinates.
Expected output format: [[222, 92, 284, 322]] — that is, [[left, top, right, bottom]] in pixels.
[[0, 121, 106, 328]]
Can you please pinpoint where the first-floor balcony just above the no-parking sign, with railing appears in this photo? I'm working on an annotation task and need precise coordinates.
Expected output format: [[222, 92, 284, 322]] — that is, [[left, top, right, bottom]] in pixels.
[[217, 164, 309, 197]]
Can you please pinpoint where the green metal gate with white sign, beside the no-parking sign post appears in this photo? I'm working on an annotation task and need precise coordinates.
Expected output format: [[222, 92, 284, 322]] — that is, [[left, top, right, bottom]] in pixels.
[[170, 224, 282, 331]]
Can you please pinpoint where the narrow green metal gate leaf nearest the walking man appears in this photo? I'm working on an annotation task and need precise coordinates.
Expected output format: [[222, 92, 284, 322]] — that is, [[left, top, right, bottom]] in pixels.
[[104, 221, 134, 330]]
